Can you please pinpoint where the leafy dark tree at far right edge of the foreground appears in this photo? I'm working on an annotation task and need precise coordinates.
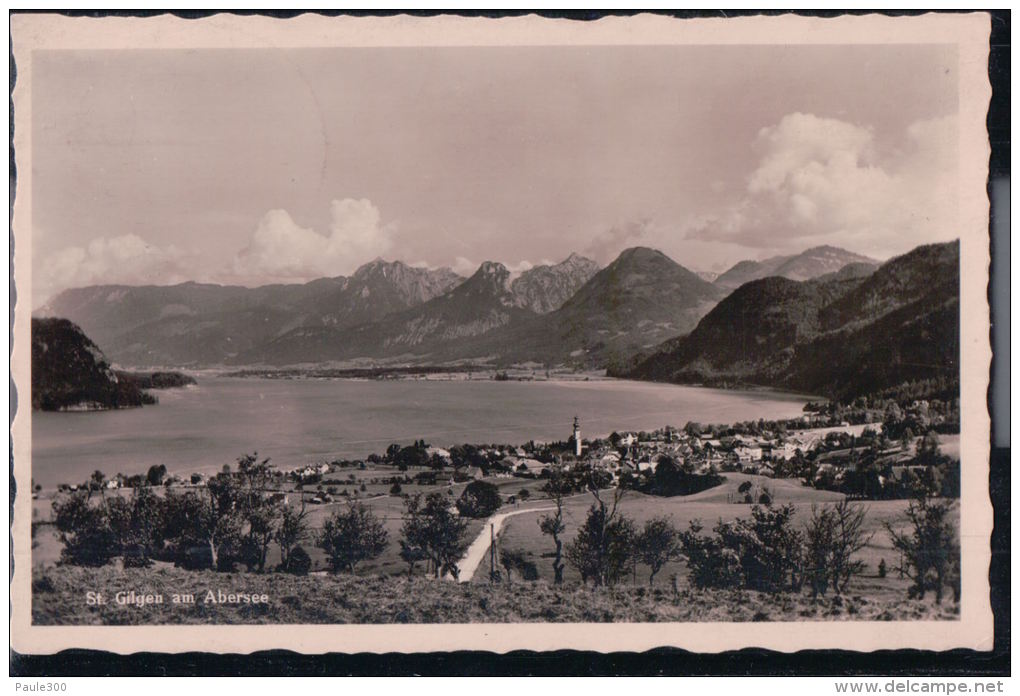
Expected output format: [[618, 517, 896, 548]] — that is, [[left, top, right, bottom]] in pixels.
[[885, 491, 960, 604]]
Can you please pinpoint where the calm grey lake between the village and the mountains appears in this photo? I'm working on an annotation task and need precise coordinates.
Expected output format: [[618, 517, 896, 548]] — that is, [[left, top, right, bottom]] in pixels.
[[32, 378, 807, 488]]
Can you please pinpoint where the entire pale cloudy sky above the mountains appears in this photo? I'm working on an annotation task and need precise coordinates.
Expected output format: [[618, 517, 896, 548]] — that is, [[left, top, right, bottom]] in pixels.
[[31, 45, 959, 302]]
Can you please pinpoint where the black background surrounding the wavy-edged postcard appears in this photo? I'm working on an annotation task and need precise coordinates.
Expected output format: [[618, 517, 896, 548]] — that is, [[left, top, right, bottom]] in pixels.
[[8, 10, 1011, 677]]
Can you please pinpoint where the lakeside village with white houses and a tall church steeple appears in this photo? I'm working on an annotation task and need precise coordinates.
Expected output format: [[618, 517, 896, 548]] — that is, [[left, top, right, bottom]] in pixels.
[[53, 393, 959, 505]]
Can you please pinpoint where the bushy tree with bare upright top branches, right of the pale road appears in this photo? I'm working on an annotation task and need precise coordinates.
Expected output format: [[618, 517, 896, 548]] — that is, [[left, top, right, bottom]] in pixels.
[[566, 489, 636, 587]]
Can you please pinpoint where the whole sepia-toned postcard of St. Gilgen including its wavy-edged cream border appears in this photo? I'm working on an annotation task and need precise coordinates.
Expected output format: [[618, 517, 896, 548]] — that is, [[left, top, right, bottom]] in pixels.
[[12, 14, 990, 649]]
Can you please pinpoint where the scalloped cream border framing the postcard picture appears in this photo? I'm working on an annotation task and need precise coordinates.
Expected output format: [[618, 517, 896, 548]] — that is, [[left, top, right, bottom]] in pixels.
[[10, 13, 992, 654]]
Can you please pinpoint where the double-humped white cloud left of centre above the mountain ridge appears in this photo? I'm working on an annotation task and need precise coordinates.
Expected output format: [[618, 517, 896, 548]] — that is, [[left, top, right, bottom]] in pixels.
[[234, 198, 393, 282]]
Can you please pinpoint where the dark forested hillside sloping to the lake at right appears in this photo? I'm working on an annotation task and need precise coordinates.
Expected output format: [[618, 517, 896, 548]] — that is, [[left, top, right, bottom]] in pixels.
[[615, 242, 960, 398]]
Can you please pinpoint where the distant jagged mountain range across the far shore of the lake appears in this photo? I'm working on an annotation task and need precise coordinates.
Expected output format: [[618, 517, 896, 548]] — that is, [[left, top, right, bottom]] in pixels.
[[36, 240, 901, 370]]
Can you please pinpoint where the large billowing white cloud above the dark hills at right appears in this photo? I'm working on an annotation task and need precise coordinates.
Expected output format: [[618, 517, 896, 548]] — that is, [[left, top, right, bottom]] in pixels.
[[686, 113, 960, 258]]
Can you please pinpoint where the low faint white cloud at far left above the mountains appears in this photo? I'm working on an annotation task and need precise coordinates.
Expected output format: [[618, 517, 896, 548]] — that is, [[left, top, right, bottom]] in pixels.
[[33, 235, 193, 304]]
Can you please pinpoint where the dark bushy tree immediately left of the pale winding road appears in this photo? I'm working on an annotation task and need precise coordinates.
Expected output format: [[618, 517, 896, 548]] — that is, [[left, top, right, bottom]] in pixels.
[[401, 493, 467, 578]]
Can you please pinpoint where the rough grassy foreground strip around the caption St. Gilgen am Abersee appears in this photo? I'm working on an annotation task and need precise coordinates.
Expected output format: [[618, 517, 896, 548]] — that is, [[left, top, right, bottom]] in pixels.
[[33, 566, 959, 626]]
